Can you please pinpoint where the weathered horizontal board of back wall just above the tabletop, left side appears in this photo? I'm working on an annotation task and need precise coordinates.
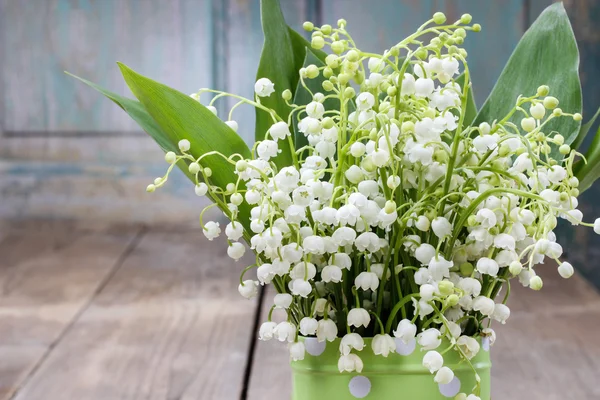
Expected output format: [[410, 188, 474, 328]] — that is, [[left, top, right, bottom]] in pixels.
[[0, 135, 208, 225]]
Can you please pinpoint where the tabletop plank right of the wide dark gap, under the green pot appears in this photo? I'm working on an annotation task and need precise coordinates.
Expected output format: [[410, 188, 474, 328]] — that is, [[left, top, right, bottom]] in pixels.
[[248, 265, 600, 400]]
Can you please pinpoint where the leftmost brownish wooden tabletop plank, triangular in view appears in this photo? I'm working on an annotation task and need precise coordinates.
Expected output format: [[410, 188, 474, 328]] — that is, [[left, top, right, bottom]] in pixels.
[[0, 228, 136, 400]]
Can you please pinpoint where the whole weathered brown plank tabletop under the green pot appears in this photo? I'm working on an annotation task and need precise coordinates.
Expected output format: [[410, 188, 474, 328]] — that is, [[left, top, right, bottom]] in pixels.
[[0, 221, 600, 400]]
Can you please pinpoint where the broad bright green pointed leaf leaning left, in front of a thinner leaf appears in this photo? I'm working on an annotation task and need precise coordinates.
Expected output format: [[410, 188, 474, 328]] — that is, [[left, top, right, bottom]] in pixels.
[[119, 63, 251, 227]]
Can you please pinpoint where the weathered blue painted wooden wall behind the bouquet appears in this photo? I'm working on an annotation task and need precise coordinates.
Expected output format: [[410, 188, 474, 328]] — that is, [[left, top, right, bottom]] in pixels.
[[0, 0, 600, 282]]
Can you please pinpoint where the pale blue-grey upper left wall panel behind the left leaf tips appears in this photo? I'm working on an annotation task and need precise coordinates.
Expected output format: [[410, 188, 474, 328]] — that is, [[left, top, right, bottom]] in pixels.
[[0, 0, 211, 132]]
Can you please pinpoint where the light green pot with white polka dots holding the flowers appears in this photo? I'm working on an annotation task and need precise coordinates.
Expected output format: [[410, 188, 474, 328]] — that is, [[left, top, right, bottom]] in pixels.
[[292, 338, 492, 400]]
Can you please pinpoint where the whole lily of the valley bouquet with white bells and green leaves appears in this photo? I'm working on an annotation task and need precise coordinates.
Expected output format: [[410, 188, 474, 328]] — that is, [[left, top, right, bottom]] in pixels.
[[71, 1, 600, 400]]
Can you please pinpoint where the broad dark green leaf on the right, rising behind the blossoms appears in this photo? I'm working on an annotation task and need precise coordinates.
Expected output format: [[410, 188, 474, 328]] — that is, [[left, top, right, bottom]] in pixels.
[[475, 3, 582, 158]]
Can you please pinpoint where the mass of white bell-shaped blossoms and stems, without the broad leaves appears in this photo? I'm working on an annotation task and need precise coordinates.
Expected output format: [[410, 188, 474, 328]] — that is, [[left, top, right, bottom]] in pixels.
[[148, 13, 600, 400]]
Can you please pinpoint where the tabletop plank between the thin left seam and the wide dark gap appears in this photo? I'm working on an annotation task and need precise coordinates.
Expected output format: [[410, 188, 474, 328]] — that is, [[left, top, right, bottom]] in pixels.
[[8, 231, 256, 400]]
